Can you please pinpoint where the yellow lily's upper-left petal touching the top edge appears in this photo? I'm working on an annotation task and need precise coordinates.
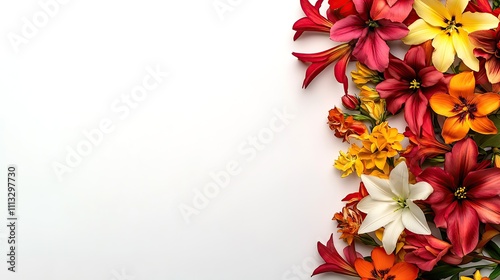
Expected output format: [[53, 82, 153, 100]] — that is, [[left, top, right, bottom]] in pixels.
[[413, 0, 451, 27]]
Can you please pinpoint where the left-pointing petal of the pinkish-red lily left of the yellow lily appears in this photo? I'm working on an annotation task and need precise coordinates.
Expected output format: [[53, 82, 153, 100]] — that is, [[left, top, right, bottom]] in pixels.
[[330, 15, 366, 42]]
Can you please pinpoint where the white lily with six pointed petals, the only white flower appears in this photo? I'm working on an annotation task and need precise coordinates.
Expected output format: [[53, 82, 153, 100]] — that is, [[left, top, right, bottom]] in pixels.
[[358, 162, 434, 254]]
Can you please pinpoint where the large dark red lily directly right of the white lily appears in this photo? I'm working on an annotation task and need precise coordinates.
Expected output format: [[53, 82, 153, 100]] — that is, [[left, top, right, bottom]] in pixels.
[[417, 138, 500, 257]]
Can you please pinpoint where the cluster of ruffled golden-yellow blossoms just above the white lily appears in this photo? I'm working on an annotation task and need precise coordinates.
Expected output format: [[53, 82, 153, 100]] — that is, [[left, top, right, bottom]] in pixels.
[[334, 122, 404, 178]]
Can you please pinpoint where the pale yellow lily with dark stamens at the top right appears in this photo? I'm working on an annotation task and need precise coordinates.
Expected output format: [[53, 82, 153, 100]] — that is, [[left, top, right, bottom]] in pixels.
[[403, 0, 499, 72]]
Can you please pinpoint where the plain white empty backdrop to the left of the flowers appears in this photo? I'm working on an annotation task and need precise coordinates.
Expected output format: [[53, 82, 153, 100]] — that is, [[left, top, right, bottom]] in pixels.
[[0, 0, 358, 280]]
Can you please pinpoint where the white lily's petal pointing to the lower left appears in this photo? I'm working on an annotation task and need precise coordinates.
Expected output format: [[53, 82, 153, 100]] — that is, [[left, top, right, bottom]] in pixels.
[[358, 202, 402, 233]]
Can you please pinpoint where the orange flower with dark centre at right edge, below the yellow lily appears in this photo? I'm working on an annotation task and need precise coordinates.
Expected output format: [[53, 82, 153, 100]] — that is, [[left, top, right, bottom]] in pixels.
[[429, 72, 500, 144]]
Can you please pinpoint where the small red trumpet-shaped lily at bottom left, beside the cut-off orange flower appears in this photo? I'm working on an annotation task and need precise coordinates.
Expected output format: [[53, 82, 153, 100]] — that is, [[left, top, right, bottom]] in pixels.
[[312, 234, 362, 276]]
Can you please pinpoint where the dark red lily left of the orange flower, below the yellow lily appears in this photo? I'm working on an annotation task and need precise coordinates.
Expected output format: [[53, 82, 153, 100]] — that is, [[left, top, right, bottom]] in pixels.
[[377, 46, 447, 135]]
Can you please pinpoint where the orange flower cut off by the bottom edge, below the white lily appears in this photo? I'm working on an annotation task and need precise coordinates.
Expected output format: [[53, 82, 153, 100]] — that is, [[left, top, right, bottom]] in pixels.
[[354, 247, 418, 280]]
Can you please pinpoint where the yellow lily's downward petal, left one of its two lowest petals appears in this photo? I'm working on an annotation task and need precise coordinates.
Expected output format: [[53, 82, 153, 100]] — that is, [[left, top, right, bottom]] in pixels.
[[432, 32, 456, 72]]
